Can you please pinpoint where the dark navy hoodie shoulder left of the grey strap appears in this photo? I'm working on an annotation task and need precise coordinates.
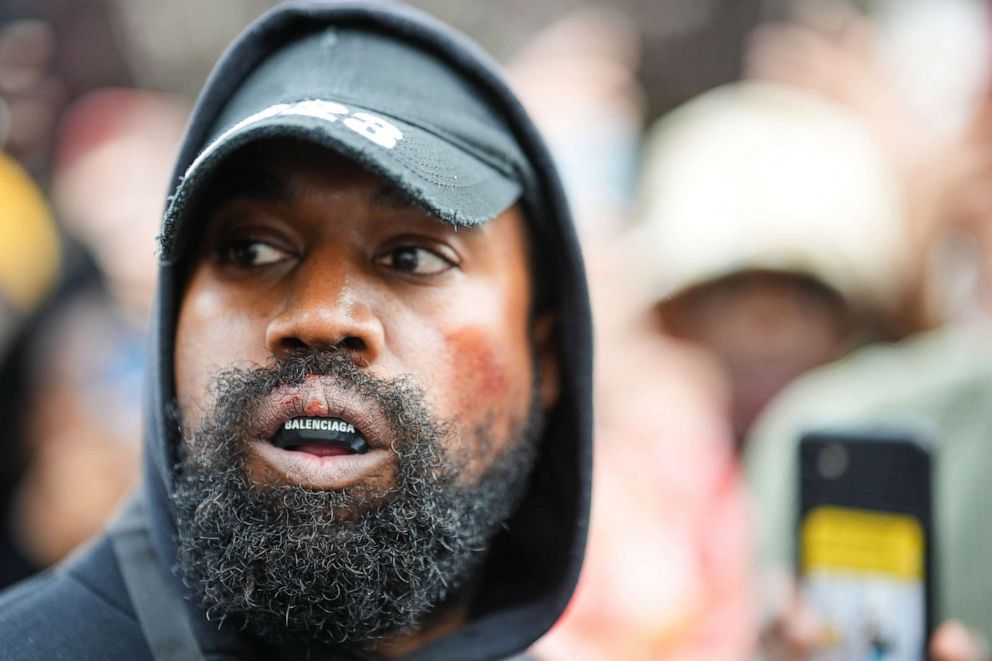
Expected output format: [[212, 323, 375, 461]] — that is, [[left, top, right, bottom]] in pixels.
[[0, 538, 151, 661]]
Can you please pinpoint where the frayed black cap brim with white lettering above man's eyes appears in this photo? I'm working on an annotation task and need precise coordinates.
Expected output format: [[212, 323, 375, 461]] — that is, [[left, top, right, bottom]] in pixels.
[[165, 102, 523, 257]]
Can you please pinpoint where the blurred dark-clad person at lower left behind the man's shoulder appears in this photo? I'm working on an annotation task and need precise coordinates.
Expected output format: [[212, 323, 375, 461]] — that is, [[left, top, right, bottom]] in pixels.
[[0, 239, 119, 584]]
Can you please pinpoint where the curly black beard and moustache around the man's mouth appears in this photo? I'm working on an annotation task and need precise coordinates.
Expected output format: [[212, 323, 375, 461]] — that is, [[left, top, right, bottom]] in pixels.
[[172, 353, 542, 646]]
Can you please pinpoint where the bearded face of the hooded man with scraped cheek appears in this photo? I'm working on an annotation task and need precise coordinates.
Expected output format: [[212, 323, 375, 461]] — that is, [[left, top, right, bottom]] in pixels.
[[174, 142, 556, 642]]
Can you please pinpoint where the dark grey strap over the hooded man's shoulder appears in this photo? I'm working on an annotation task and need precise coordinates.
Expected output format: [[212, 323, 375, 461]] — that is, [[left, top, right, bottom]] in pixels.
[[109, 492, 205, 661]]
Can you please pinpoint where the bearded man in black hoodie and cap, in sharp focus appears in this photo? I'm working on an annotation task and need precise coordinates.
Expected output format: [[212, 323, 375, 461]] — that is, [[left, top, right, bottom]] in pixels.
[[0, 4, 590, 659]]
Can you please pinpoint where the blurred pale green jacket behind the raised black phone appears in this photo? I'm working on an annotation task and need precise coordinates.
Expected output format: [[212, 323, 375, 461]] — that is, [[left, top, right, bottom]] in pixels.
[[745, 328, 992, 637]]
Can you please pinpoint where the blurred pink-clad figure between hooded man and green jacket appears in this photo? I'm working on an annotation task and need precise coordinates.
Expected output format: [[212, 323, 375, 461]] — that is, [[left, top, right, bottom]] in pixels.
[[536, 292, 756, 661]]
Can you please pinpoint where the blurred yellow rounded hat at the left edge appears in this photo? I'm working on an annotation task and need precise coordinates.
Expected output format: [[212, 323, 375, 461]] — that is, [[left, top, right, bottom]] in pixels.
[[0, 153, 60, 314]]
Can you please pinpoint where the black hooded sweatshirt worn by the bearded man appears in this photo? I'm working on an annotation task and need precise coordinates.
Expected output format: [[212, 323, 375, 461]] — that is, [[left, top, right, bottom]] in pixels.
[[0, 3, 592, 660]]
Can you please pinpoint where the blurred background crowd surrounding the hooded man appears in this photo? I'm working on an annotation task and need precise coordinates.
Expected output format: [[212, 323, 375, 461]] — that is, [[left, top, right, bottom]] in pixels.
[[0, 0, 992, 659]]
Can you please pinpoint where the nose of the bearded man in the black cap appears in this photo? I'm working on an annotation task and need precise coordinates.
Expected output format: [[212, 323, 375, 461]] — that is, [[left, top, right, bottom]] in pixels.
[[265, 254, 385, 365]]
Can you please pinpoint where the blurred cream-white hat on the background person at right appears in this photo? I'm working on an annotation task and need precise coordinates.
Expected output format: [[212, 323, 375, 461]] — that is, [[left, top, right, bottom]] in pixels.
[[632, 82, 908, 308]]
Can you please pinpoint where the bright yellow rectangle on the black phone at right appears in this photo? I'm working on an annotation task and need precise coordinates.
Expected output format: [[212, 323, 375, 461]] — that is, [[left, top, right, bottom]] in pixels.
[[800, 506, 924, 581]]
